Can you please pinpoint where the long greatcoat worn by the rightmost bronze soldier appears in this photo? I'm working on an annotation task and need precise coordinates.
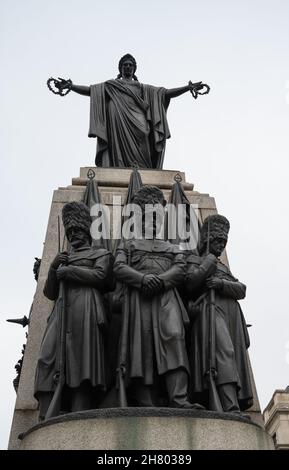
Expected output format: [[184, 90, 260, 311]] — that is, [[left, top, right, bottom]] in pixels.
[[186, 254, 253, 410]]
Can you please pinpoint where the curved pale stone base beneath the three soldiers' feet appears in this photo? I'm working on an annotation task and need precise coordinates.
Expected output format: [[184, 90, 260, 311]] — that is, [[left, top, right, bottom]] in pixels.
[[20, 408, 274, 450]]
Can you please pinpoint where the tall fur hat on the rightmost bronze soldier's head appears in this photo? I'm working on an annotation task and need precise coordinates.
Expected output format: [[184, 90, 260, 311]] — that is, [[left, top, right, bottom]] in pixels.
[[200, 214, 230, 253]]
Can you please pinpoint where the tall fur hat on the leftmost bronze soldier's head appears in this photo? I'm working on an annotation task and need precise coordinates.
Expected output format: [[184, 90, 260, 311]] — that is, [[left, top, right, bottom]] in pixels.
[[62, 202, 92, 235]]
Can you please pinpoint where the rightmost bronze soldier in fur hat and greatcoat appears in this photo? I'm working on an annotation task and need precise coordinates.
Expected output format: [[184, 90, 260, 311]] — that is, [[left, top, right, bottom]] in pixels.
[[185, 215, 253, 413]]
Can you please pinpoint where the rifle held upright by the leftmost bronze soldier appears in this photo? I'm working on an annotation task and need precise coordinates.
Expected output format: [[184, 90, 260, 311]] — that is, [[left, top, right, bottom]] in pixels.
[[45, 216, 66, 419]]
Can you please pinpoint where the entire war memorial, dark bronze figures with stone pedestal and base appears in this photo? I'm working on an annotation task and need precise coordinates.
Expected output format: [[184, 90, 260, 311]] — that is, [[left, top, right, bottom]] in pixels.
[[6, 48, 273, 452]]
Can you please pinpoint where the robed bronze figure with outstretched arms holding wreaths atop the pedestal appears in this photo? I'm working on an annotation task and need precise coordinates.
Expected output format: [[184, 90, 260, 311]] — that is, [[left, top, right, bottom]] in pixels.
[[47, 54, 210, 168]]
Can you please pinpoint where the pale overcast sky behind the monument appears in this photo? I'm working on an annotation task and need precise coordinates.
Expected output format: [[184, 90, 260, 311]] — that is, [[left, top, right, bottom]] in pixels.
[[0, 0, 289, 448]]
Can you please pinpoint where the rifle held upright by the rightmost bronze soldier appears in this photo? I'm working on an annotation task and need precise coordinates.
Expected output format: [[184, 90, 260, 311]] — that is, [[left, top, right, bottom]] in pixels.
[[205, 220, 223, 413]]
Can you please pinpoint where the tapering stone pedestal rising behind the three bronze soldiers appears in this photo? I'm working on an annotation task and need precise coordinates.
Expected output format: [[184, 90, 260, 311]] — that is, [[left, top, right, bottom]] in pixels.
[[9, 167, 263, 449]]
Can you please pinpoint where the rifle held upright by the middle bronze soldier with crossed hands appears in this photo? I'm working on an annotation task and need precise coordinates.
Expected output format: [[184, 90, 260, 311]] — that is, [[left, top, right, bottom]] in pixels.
[[116, 242, 131, 408]]
